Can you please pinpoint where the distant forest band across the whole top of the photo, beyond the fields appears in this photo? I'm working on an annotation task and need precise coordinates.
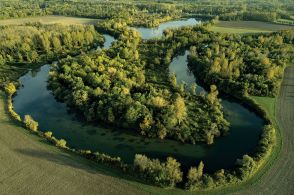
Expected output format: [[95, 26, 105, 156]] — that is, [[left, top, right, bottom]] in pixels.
[[0, 0, 294, 27]]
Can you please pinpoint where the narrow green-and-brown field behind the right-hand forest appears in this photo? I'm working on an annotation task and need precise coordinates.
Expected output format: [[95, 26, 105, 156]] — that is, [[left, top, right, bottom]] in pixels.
[[211, 21, 293, 33]]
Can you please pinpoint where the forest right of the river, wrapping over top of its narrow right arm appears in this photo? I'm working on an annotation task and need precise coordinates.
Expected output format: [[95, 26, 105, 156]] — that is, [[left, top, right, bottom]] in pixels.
[[141, 21, 294, 96]]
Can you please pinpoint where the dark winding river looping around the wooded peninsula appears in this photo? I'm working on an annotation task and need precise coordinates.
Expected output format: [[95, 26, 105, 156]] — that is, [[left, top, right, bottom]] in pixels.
[[13, 19, 264, 172]]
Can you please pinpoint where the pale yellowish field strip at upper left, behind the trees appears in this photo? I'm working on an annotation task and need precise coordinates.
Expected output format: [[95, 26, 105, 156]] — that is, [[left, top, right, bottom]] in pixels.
[[0, 16, 99, 25]]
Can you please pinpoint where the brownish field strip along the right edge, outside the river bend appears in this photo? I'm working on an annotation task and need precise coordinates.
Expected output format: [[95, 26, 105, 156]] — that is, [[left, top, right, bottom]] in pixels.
[[238, 66, 294, 195]]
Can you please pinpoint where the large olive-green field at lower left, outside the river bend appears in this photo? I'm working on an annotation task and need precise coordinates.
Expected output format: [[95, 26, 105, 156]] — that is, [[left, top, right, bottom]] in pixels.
[[0, 91, 149, 195]]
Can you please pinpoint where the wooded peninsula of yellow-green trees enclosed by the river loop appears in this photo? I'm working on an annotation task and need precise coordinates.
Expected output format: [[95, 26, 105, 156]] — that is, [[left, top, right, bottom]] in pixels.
[[50, 21, 229, 144]]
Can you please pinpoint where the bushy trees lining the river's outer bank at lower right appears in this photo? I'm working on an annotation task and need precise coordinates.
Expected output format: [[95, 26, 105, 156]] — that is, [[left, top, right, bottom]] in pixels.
[[134, 125, 276, 191]]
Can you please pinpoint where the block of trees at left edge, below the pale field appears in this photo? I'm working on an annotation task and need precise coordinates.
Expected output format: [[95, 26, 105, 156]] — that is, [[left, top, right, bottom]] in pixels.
[[0, 23, 104, 88]]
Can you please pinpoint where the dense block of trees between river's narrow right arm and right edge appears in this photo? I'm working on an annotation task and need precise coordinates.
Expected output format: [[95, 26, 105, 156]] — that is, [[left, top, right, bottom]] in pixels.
[[189, 27, 294, 97]]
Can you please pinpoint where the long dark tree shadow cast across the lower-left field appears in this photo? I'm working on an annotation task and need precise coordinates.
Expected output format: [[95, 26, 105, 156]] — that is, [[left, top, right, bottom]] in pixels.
[[15, 149, 152, 186]]
